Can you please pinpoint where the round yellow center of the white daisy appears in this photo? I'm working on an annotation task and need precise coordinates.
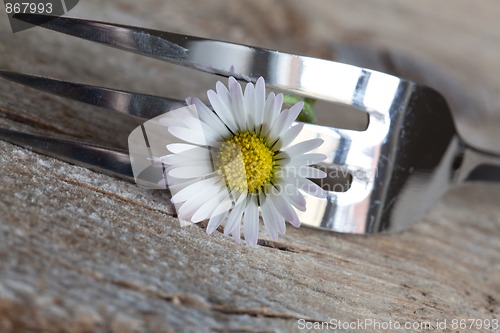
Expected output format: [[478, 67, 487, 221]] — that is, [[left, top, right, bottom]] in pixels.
[[214, 132, 276, 193]]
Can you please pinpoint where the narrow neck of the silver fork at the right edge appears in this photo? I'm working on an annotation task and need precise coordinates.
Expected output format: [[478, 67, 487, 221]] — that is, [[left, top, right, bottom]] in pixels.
[[455, 140, 500, 184]]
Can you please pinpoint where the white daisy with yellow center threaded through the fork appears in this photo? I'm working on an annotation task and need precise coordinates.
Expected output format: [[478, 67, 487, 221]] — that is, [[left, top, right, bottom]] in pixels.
[[160, 77, 326, 246]]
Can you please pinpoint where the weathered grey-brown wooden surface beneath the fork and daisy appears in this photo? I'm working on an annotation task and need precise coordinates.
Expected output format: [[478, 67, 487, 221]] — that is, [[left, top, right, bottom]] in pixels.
[[0, 0, 500, 332]]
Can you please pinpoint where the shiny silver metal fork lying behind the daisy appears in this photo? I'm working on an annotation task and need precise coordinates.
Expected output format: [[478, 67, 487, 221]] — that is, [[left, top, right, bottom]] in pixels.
[[0, 14, 500, 234]]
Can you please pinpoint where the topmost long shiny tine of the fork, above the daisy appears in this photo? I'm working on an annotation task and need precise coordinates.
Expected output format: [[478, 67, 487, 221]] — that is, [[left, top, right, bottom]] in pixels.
[[13, 14, 368, 107]]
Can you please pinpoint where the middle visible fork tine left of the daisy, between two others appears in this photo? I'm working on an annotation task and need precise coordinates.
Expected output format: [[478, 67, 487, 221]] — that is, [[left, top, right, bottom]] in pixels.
[[0, 71, 186, 120]]
